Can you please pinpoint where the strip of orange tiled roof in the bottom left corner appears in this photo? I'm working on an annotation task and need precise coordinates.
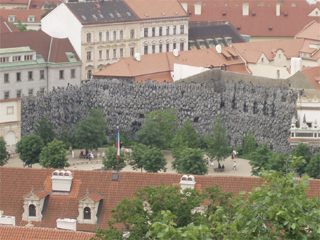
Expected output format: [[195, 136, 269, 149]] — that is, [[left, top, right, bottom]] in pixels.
[[0, 225, 95, 240]]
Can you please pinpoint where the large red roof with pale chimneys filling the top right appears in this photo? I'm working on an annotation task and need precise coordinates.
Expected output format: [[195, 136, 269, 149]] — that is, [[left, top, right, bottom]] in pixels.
[[181, 0, 320, 37]]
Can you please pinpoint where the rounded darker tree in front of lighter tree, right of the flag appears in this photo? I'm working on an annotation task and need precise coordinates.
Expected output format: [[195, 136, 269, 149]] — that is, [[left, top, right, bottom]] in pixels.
[[136, 121, 165, 149]]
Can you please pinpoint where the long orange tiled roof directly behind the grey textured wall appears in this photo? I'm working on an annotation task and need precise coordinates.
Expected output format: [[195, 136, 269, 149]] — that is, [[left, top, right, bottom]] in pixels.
[[93, 47, 248, 82]]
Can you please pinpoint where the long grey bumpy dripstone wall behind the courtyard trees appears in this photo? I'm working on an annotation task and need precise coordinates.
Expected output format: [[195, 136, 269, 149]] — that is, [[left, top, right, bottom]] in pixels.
[[22, 70, 297, 152]]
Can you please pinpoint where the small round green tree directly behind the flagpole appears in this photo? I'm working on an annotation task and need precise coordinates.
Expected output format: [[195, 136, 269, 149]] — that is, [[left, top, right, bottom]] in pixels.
[[102, 147, 126, 171]]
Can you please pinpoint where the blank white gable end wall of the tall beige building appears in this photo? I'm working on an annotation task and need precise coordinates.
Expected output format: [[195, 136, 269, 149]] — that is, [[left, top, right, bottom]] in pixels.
[[41, 3, 82, 58]]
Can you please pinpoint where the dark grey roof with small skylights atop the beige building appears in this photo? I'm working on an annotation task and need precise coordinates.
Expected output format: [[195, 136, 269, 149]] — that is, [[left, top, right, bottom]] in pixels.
[[66, 0, 139, 25]]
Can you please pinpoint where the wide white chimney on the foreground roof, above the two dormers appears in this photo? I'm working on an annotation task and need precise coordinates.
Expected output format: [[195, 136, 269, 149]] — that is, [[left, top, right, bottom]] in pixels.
[[51, 170, 73, 194]]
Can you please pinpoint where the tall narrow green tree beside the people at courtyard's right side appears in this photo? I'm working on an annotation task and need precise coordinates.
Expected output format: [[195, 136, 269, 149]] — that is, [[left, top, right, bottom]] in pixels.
[[206, 116, 229, 162]]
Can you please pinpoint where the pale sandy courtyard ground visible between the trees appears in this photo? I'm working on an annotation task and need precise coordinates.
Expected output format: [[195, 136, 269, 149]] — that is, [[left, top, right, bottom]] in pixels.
[[5, 148, 251, 176]]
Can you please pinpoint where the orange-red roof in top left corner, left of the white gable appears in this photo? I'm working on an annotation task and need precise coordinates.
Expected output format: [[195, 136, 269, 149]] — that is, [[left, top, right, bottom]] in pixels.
[[0, 9, 46, 23]]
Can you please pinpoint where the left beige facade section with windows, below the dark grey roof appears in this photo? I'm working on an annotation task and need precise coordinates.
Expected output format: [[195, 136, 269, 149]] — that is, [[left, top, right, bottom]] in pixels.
[[81, 22, 140, 80]]
